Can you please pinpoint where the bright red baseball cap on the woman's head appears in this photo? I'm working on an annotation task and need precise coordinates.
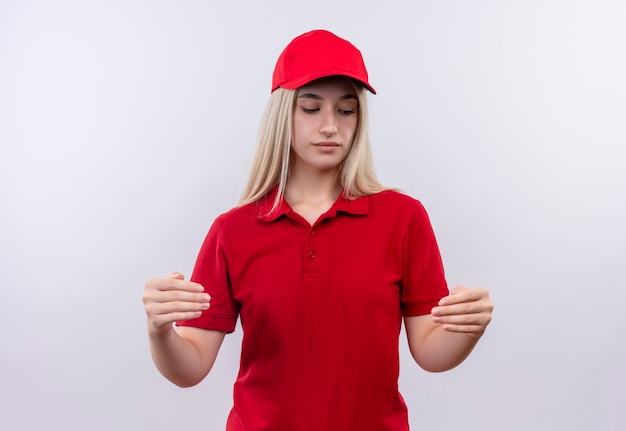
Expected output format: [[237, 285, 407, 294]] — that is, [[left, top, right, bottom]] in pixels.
[[272, 30, 376, 94]]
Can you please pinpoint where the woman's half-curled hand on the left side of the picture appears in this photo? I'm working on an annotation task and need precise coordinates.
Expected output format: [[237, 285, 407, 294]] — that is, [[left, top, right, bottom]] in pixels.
[[142, 272, 211, 336]]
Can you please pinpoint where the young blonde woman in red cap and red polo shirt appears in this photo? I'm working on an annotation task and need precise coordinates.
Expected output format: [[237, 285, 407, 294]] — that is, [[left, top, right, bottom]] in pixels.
[[143, 30, 493, 431]]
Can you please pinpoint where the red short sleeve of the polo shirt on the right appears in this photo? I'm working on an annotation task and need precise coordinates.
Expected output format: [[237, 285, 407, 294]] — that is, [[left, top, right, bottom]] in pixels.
[[400, 202, 449, 316]]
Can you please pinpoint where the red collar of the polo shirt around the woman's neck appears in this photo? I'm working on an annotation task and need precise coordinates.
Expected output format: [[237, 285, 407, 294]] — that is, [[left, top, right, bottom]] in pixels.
[[257, 187, 370, 222]]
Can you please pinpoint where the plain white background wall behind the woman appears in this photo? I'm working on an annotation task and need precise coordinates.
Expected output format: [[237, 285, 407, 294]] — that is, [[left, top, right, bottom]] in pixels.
[[0, 0, 626, 431]]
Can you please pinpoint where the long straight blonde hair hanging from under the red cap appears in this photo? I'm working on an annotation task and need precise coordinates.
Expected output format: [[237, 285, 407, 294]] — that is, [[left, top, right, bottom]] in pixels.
[[239, 80, 387, 211]]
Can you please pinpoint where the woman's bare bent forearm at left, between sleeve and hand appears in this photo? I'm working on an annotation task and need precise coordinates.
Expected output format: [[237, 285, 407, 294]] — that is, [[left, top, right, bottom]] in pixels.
[[149, 328, 223, 387]]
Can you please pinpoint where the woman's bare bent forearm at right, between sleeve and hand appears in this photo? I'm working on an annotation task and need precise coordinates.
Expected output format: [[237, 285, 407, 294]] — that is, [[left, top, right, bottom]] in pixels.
[[409, 325, 479, 372]]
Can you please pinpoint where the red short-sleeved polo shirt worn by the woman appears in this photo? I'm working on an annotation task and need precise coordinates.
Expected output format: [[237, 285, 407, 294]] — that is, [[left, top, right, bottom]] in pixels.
[[179, 191, 448, 431]]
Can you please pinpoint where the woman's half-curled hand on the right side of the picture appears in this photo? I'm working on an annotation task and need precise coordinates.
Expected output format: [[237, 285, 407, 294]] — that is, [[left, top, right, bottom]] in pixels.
[[432, 286, 493, 338]]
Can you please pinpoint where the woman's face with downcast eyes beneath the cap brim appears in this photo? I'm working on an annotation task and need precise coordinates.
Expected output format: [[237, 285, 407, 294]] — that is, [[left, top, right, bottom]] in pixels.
[[291, 77, 359, 172]]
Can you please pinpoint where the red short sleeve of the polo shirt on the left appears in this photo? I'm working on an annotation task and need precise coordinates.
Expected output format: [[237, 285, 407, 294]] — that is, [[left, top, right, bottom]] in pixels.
[[176, 216, 239, 333]]
